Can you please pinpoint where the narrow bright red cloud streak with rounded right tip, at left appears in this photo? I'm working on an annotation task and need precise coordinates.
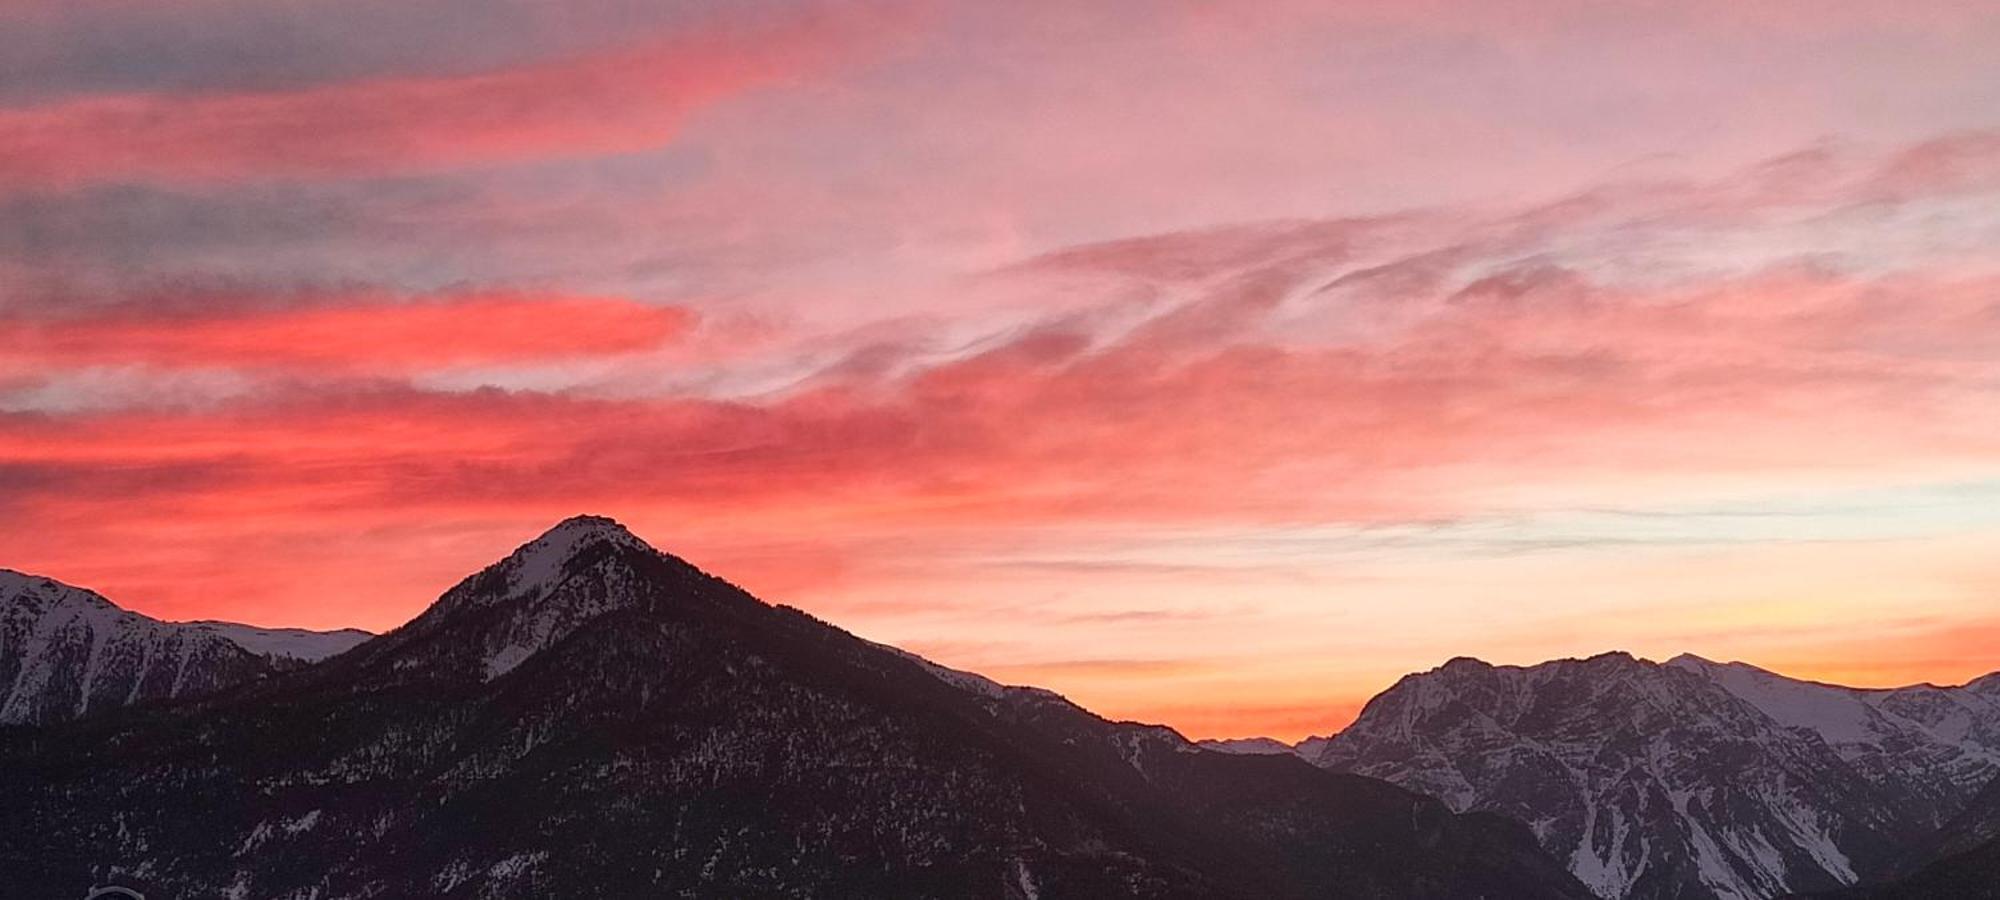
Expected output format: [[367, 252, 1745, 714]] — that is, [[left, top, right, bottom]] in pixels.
[[0, 292, 692, 374]]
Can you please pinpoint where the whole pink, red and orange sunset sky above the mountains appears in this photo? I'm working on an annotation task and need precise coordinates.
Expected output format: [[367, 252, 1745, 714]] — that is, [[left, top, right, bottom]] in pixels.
[[0, 0, 2000, 738]]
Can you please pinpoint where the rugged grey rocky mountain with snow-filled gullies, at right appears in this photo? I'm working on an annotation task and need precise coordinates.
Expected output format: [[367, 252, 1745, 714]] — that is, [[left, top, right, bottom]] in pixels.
[[1298, 654, 2000, 900]]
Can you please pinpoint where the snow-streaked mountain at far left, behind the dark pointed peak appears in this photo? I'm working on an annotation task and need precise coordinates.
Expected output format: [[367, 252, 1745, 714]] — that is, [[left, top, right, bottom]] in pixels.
[[0, 570, 370, 724]]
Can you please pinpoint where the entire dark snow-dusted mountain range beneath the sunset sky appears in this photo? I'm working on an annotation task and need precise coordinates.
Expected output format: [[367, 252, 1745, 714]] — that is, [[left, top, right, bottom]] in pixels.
[[0, 516, 2000, 900]]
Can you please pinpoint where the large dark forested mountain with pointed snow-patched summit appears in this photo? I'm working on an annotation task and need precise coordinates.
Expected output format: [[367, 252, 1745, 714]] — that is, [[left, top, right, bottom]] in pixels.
[[0, 518, 1588, 900]]
